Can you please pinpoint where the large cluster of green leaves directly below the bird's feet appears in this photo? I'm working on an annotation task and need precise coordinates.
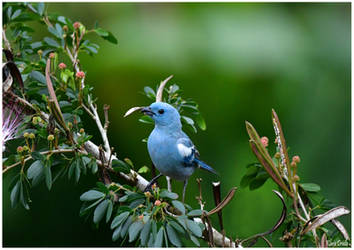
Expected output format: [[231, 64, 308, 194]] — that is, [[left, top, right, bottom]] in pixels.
[[80, 182, 204, 247]]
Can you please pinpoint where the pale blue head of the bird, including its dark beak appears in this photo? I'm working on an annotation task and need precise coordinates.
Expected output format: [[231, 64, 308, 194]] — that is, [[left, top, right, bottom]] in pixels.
[[141, 102, 181, 127]]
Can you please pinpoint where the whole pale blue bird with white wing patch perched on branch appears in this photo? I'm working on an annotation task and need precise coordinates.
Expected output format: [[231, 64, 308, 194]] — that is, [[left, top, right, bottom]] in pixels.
[[141, 102, 217, 202]]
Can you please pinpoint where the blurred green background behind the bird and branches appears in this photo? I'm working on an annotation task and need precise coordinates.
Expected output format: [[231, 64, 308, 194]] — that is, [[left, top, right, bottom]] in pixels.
[[3, 3, 351, 246]]
